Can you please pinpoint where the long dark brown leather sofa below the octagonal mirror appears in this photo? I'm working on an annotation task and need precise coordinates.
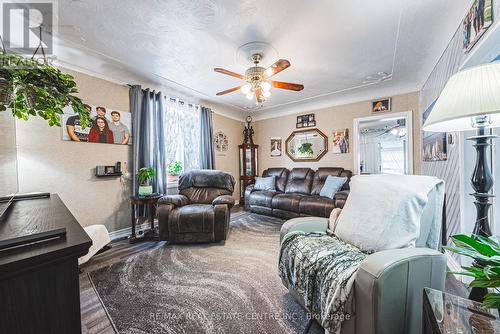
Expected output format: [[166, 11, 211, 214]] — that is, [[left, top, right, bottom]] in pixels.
[[245, 167, 352, 219]]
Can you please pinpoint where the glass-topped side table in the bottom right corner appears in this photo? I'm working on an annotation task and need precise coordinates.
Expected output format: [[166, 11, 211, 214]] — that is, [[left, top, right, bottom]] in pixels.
[[422, 288, 500, 334]]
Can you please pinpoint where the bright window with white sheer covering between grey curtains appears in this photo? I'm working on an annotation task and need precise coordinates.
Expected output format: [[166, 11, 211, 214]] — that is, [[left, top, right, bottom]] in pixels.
[[165, 99, 201, 177]]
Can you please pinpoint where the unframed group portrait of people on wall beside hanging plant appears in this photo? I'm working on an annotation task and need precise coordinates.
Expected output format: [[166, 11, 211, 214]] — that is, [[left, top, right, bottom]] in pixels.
[[61, 104, 132, 145]]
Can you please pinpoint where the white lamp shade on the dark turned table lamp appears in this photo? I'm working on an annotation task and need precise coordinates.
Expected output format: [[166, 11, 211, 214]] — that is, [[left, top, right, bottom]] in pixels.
[[423, 62, 500, 132]]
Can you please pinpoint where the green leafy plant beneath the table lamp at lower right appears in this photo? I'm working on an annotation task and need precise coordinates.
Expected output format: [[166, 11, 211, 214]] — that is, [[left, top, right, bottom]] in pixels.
[[443, 234, 500, 309]]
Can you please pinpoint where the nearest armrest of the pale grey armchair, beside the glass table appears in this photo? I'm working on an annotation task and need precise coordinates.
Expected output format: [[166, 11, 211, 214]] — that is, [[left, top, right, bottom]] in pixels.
[[354, 248, 446, 334]]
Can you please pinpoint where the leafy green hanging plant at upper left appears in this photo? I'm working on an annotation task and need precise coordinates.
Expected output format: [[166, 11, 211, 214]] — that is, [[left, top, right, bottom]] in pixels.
[[0, 52, 90, 127]]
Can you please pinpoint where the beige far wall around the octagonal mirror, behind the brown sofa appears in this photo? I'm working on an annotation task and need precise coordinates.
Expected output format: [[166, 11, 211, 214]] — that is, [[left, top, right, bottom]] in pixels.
[[254, 92, 421, 174]]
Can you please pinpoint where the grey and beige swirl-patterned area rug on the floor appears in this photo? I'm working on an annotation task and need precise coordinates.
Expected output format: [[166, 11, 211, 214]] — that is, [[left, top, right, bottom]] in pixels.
[[89, 212, 320, 334]]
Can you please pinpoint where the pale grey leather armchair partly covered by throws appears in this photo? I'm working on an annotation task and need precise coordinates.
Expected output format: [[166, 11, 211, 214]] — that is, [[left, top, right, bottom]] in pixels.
[[280, 183, 446, 334]]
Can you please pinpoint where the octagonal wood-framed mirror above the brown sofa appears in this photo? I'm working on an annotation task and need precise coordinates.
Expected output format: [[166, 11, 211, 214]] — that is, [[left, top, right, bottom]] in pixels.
[[285, 129, 328, 162]]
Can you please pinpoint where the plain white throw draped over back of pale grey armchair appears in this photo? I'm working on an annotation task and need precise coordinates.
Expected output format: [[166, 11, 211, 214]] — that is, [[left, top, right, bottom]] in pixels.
[[335, 175, 443, 252]]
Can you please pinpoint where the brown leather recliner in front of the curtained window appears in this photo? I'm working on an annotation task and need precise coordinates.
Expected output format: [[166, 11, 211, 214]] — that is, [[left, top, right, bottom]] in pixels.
[[158, 170, 235, 243]]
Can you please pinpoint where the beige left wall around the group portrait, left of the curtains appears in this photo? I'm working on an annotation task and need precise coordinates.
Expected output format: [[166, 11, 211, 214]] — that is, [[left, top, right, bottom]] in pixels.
[[16, 70, 132, 231]]
